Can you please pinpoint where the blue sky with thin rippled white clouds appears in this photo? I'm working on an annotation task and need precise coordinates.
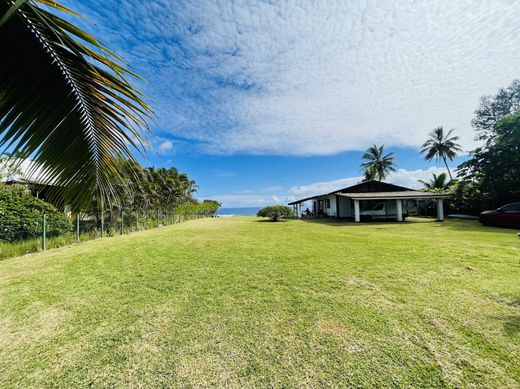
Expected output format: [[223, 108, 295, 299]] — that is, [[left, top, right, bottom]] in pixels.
[[66, 0, 520, 206]]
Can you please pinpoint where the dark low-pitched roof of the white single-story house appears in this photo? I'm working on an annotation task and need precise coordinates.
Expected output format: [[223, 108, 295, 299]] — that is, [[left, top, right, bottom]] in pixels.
[[289, 180, 448, 205]]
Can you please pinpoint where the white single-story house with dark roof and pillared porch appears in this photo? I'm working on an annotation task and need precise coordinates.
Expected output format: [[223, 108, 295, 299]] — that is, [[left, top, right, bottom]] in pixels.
[[289, 181, 449, 222]]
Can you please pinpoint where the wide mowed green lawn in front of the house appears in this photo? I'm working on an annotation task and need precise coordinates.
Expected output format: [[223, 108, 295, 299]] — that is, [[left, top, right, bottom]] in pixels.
[[0, 217, 520, 388]]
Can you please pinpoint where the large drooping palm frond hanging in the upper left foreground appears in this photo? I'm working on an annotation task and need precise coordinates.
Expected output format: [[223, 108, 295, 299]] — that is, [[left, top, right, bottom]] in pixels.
[[0, 0, 152, 207]]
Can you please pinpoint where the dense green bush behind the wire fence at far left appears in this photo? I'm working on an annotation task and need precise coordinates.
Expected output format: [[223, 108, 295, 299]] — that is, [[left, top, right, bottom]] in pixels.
[[0, 185, 72, 242]]
